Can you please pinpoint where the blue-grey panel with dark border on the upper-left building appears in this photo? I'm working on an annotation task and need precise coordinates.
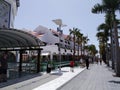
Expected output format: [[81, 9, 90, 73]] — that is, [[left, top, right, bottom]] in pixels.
[[0, 0, 11, 28]]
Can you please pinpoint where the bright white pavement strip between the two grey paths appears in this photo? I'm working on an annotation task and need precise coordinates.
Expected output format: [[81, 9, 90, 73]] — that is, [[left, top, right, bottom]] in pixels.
[[33, 68, 85, 90]]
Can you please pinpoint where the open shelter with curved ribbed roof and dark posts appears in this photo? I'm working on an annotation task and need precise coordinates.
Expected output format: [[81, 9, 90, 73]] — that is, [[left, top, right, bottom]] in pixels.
[[0, 28, 44, 77]]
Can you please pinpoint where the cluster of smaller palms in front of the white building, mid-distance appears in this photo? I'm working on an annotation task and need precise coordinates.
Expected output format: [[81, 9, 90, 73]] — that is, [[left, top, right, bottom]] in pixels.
[[69, 28, 97, 60]]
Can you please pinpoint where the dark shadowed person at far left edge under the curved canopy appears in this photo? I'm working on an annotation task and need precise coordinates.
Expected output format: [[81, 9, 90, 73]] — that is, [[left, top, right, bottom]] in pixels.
[[0, 53, 8, 82]]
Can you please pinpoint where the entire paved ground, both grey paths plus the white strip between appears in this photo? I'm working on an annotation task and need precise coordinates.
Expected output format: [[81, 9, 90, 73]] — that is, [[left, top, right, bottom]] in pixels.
[[0, 64, 120, 90]]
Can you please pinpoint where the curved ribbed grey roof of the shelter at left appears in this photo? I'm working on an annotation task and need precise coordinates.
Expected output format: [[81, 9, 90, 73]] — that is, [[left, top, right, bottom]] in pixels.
[[0, 28, 44, 50]]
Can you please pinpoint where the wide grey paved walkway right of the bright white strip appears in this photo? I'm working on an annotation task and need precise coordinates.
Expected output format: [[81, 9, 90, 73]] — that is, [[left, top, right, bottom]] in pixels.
[[58, 64, 120, 90]]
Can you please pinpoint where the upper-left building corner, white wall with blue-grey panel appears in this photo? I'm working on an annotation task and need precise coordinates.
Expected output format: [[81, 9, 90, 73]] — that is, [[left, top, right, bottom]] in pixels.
[[0, 0, 20, 28]]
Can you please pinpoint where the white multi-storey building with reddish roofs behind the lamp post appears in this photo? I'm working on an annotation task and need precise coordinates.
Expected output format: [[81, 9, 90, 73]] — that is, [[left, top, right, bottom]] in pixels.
[[30, 25, 81, 60]]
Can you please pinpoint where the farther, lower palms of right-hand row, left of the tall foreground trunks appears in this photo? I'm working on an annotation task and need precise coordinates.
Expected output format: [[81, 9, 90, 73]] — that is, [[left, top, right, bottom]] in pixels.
[[96, 14, 110, 66]]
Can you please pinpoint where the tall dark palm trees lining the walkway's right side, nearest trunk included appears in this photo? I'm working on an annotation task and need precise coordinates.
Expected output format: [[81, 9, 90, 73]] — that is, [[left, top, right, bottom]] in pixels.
[[92, 0, 120, 76]]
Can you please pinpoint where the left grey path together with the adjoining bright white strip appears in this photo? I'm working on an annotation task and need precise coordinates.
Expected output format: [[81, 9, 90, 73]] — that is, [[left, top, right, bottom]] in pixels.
[[0, 67, 85, 90]]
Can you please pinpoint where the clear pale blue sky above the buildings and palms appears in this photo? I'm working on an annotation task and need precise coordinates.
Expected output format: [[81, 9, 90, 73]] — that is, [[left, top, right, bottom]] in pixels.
[[14, 0, 119, 49]]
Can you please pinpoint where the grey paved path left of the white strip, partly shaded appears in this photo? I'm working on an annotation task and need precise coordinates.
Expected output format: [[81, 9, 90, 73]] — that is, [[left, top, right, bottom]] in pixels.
[[0, 73, 60, 90]]
